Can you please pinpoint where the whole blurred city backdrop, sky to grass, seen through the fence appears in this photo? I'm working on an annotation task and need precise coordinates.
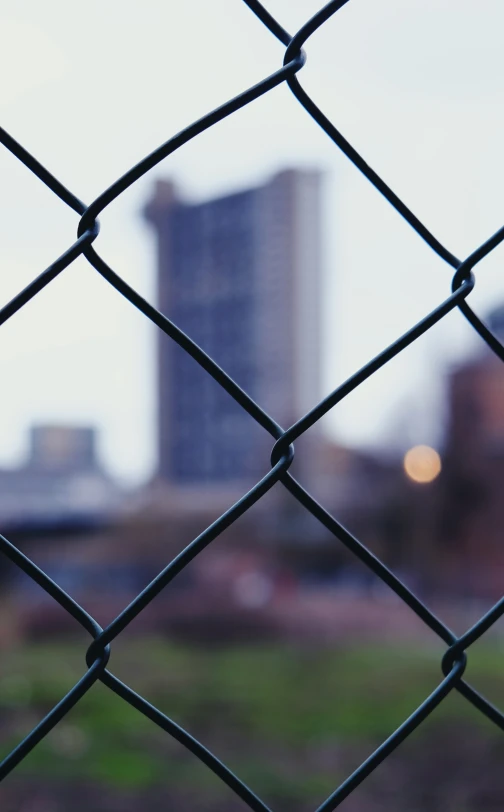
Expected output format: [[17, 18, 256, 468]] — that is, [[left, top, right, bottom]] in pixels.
[[0, 0, 504, 812]]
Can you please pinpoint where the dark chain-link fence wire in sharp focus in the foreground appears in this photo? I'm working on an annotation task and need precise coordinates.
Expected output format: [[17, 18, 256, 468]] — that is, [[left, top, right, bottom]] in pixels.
[[0, 0, 504, 812]]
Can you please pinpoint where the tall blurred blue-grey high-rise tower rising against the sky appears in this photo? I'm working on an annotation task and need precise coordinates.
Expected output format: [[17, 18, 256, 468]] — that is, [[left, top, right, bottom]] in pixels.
[[145, 170, 321, 486]]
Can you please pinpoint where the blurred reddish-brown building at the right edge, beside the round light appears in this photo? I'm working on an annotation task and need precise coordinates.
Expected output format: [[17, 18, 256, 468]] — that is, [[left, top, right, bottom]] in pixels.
[[436, 307, 504, 599]]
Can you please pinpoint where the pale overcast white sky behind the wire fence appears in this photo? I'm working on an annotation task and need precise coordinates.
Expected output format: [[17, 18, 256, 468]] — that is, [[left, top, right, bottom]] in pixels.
[[0, 0, 504, 481]]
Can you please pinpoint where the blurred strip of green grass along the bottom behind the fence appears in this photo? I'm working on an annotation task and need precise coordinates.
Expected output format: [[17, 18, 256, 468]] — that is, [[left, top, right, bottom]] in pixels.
[[0, 638, 504, 799]]
